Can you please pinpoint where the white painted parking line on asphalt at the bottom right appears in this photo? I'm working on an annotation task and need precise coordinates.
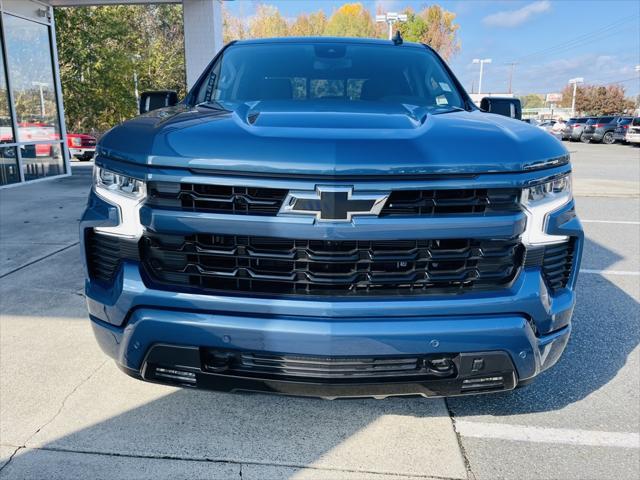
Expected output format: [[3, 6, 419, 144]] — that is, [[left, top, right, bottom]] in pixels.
[[456, 420, 640, 448]]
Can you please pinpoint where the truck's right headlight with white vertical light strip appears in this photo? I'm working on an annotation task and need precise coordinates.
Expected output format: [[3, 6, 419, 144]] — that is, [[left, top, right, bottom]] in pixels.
[[521, 173, 572, 245]]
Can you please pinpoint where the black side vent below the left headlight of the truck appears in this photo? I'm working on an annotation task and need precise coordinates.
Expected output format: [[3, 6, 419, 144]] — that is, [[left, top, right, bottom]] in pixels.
[[85, 229, 139, 283]]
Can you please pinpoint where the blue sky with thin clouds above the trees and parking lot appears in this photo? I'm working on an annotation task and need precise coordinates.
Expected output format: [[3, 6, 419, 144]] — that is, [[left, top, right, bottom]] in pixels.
[[225, 0, 640, 96]]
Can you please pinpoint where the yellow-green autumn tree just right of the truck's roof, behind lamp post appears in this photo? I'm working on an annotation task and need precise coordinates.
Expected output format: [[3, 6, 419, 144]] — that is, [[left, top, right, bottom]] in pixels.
[[398, 5, 460, 60]]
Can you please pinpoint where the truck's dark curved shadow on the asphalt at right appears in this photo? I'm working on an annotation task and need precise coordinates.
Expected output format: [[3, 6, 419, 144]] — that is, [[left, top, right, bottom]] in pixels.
[[448, 239, 640, 416]]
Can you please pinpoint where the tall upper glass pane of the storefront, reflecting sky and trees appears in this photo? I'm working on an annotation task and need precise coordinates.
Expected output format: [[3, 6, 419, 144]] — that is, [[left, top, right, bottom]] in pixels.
[[3, 14, 60, 142]]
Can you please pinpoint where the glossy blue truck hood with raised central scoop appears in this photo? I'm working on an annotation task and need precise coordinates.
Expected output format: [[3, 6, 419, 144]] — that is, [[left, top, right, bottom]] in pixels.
[[98, 100, 567, 176]]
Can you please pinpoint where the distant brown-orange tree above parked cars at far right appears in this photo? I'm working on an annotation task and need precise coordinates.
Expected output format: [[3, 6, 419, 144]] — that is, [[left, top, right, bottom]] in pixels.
[[561, 84, 634, 115]]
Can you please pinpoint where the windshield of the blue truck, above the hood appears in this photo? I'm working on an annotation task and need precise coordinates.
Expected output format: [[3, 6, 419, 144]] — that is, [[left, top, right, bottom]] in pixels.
[[196, 42, 464, 109]]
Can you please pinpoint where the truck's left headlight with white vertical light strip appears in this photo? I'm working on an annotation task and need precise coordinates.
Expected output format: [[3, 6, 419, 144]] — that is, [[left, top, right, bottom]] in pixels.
[[93, 166, 147, 238]]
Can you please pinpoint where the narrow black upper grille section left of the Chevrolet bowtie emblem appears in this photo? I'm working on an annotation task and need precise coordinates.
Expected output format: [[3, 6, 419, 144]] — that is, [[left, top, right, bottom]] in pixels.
[[147, 182, 287, 216]]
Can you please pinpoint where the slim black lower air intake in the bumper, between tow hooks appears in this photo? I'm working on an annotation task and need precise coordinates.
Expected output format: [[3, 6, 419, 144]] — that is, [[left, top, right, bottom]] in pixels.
[[202, 349, 457, 383]]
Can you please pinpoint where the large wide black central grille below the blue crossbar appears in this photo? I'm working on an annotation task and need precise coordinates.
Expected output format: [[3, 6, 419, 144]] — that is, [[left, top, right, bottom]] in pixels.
[[142, 234, 522, 295]]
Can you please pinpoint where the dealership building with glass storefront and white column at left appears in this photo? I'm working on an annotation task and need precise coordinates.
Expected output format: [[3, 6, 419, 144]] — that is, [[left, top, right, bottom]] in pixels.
[[0, 0, 222, 188]]
